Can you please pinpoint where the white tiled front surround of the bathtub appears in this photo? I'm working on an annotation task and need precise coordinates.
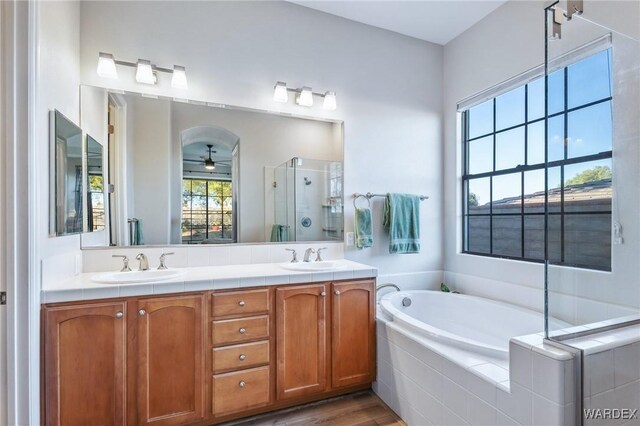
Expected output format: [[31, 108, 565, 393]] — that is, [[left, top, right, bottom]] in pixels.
[[374, 314, 575, 425]]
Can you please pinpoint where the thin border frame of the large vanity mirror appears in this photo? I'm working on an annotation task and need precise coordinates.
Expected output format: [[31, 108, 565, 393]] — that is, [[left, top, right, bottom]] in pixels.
[[80, 84, 346, 250]]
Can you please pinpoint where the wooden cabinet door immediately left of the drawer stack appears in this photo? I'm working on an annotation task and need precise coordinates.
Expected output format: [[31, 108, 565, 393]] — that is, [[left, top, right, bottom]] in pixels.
[[135, 295, 205, 425]]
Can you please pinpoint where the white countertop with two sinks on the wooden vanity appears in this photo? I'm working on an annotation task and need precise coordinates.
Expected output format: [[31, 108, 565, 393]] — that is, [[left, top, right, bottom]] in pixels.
[[40, 260, 378, 303]]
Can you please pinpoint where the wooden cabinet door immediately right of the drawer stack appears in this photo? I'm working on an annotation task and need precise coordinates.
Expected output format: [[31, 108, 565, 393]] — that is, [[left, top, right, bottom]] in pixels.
[[276, 284, 328, 400]]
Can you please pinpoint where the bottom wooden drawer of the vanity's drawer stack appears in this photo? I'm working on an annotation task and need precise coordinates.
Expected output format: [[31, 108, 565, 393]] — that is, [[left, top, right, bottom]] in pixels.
[[213, 366, 269, 417]]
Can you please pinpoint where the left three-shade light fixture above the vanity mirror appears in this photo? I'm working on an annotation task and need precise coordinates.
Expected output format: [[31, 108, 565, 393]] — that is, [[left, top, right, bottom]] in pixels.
[[98, 52, 189, 90]]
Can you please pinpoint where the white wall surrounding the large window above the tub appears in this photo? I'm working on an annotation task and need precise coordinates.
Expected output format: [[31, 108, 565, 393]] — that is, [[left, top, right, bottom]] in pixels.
[[444, 1, 640, 322]]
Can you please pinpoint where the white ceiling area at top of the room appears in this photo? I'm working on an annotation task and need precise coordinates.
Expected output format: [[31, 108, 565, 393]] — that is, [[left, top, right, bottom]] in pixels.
[[292, 0, 507, 45]]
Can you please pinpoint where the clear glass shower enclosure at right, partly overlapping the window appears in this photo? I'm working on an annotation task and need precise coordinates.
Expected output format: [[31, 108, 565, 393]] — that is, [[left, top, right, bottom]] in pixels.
[[544, 1, 640, 425]]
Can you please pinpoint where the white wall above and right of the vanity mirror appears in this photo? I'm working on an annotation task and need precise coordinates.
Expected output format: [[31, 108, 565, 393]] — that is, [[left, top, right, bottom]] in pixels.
[[81, 2, 442, 283]]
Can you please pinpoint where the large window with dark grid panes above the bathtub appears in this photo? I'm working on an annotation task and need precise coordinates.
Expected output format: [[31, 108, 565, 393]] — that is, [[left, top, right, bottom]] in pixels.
[[462, 49, 612, 270]]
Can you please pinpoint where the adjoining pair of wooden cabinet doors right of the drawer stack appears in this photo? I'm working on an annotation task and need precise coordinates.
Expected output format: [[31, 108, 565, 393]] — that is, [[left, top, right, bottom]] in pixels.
[[276, 280, 376, 400]]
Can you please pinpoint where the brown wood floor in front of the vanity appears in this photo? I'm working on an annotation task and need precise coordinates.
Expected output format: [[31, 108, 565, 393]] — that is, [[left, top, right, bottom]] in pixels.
[[227, 391, 406, 426]]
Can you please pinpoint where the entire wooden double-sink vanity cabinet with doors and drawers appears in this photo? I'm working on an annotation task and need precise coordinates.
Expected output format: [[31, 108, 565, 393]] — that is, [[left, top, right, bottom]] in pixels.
[[42, 279, 376, 426]]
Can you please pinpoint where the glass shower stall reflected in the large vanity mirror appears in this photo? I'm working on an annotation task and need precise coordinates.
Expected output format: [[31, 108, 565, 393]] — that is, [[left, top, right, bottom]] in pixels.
[[271, 157, 344, 242]]
